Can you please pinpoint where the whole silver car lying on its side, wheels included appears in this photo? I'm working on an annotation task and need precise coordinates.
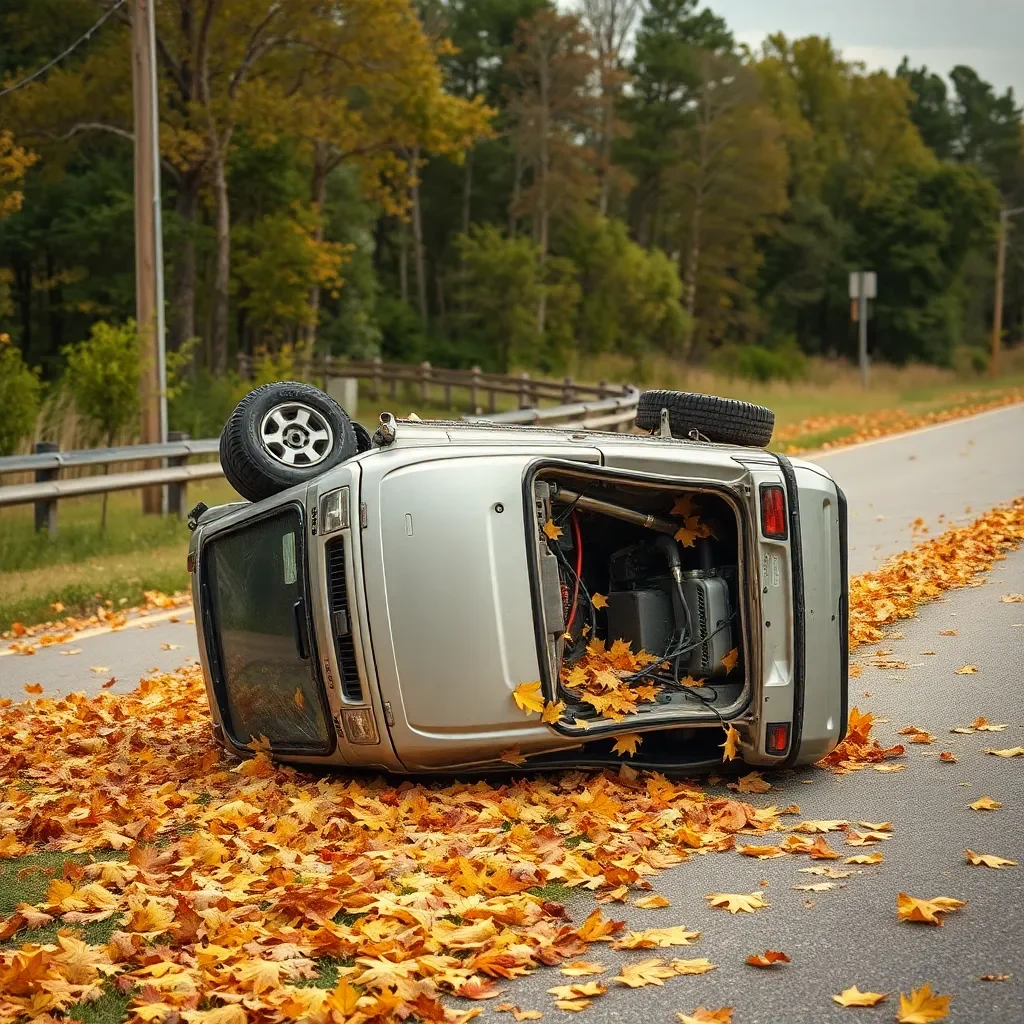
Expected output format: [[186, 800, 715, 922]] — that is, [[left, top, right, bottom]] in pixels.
[[188, 382, 848, 772]]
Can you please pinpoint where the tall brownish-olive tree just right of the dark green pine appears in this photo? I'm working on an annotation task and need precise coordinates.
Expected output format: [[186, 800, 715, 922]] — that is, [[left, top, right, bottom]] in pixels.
[[664, 52, 788, 357]]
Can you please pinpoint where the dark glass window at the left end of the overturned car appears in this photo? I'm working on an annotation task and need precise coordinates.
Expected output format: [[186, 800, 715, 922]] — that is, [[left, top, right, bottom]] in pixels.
[[204, 506, 331, 751]]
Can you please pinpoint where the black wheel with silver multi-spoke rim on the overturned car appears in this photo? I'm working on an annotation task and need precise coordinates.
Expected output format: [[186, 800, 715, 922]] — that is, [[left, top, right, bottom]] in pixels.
[[220, 381, 357, 502]]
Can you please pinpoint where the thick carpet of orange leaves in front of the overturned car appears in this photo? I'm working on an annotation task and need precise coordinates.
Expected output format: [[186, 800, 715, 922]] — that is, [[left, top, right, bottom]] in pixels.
[[0, 669, 781, 1024]]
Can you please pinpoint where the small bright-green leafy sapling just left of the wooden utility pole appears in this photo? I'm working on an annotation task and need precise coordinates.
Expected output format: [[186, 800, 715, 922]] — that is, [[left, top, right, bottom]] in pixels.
[[63, 321, 141, 531]]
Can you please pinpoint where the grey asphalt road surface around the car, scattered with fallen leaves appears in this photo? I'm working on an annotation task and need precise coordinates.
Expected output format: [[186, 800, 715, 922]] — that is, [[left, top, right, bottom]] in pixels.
[[0, 407, 1024, 1024]]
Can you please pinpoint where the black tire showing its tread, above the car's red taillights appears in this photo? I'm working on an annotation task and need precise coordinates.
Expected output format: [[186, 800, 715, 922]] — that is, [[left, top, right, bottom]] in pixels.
[[637, 391, 775, 447]]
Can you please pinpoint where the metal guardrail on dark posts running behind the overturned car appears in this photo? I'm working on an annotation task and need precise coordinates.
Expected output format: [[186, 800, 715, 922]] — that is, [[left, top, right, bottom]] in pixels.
[[0, 374, 640, 537]]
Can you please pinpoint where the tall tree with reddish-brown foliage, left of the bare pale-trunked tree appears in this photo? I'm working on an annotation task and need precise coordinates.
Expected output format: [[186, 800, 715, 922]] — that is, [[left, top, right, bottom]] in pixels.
[[508, 9, 596, 334]]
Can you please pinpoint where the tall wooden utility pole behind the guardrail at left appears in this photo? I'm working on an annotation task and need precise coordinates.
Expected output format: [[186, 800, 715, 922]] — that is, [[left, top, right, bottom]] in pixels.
[[131, 0, 167, 514]]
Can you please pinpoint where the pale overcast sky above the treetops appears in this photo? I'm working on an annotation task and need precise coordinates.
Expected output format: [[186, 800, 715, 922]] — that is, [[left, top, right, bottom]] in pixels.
[[706, 0, 1024, 103]]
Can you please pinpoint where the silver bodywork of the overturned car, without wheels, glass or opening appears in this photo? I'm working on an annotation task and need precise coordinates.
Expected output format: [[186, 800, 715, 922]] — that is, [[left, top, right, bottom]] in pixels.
[[191, 421, 846, 771]]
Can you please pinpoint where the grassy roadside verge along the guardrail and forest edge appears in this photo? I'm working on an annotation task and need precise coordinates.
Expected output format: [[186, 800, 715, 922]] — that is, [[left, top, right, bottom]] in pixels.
[[0, 360, 1024, 630]]
